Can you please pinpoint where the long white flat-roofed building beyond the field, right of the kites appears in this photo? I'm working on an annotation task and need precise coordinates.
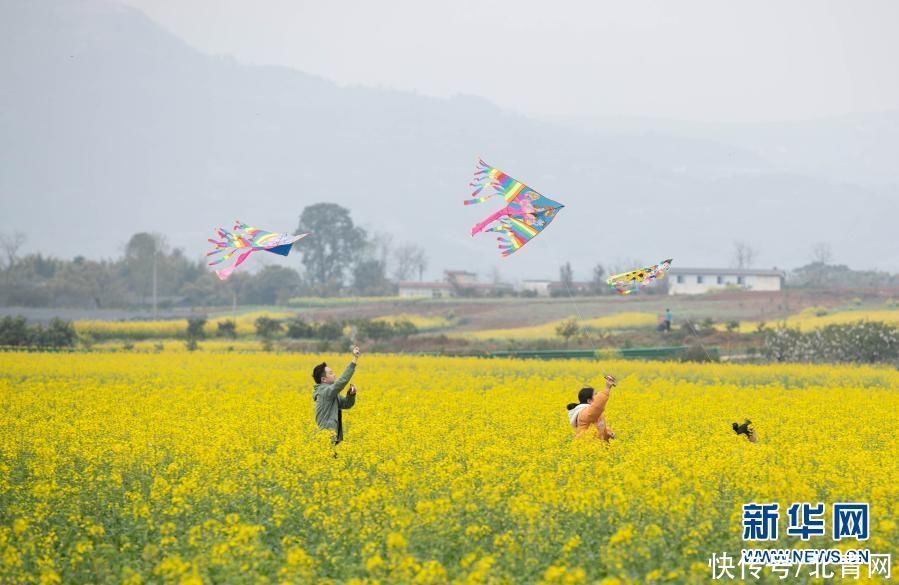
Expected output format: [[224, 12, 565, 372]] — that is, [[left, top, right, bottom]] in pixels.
[[666, 266, 785, 295]]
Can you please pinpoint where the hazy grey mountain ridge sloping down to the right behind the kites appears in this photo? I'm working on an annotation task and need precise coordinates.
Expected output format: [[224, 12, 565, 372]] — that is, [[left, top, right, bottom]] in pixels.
[[0, 0, 899, 278]]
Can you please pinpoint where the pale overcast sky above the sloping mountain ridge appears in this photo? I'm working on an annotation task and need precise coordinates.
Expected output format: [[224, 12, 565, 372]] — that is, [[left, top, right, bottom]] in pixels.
[[120, 0, 899, 121]]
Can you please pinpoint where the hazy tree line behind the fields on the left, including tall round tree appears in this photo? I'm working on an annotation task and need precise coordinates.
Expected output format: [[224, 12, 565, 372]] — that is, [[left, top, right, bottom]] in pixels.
[[0, 203, 428, 308]]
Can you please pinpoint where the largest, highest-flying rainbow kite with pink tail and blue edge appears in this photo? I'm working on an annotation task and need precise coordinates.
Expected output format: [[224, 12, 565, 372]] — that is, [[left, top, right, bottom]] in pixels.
[[465, 160, 565, 256]]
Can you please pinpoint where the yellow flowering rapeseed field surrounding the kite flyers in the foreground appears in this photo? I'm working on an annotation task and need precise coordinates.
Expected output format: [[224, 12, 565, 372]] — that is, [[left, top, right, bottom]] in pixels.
[[0, 352, 899, 585]]
